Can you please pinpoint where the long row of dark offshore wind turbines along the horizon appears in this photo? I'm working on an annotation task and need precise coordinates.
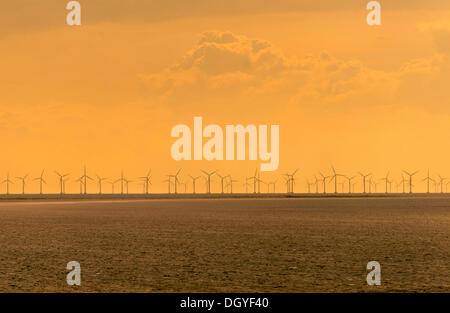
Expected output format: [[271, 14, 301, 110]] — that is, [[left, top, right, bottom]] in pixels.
[[0, 165, 450, 199]]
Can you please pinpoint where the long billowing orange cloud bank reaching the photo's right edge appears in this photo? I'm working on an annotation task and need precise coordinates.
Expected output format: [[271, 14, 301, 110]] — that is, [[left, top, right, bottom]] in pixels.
[[142, 31, 449, 115]]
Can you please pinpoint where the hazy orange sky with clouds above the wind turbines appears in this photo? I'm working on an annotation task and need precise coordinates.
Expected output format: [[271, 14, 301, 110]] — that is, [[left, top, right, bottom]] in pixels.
[[0, 0, 450, 193]]
